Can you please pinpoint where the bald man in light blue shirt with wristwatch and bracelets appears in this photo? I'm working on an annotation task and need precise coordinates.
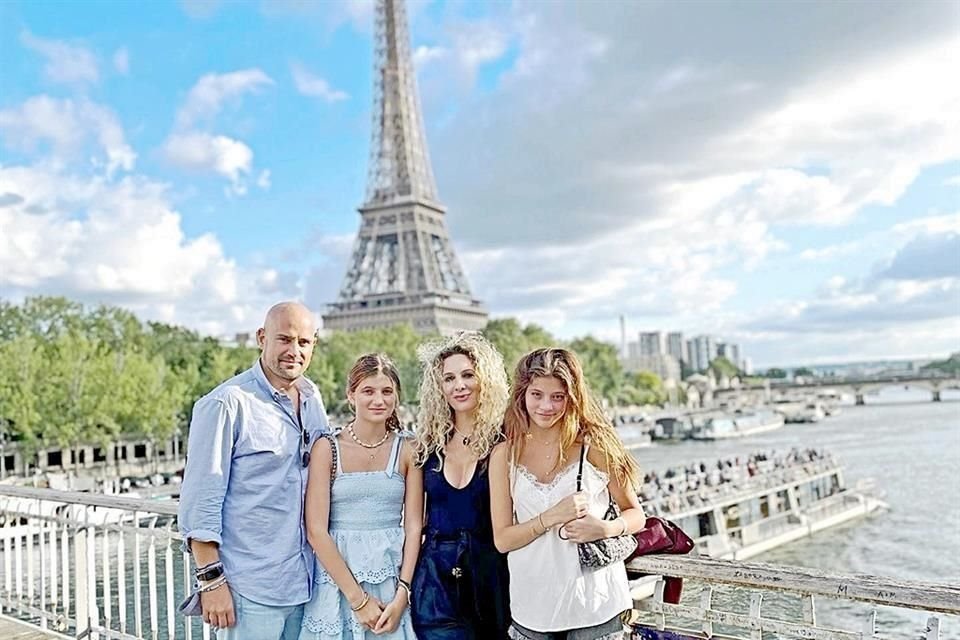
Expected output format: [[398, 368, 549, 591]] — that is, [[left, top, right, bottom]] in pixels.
[[179, 302, 328, 640]]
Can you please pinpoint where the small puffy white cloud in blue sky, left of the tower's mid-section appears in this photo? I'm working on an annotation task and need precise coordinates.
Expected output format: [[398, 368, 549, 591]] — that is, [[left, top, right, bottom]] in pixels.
[[163, 132, 255, 195]]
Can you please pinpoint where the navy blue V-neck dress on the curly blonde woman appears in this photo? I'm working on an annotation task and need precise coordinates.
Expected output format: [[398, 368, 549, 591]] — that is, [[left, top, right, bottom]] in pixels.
[[411, 454, 510, 640]]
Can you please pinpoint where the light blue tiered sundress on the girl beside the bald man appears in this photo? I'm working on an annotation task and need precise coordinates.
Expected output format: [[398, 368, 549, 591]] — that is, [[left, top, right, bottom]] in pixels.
[[300, 434, 416, 640]]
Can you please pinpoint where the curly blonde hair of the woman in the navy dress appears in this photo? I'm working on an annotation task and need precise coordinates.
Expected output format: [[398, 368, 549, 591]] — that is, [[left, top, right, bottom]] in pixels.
[[414, 331, 509, 468]]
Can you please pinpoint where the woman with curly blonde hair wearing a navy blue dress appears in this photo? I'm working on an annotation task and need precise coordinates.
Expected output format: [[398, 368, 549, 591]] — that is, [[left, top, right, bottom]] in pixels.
[[411, 332, 510, 640]]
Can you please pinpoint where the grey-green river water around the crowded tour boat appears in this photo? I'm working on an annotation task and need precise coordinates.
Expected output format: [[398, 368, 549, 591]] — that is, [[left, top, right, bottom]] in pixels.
[[636, 389, 960, 640]]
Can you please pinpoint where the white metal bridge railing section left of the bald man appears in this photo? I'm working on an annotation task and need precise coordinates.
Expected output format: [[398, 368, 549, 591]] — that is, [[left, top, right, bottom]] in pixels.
[[0, 485, 210, 640]]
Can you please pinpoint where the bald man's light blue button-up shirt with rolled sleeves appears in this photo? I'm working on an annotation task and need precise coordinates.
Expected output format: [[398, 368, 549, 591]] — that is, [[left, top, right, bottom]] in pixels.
[[178, 360, 329, 606]]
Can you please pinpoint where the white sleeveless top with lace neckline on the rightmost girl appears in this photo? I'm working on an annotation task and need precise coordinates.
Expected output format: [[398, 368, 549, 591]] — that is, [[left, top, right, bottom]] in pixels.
[[507, 455, 633, 633]]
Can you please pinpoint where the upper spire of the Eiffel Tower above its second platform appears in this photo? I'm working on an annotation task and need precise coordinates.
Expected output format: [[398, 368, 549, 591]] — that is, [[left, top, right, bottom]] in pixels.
[[364, 0, 437, 208]]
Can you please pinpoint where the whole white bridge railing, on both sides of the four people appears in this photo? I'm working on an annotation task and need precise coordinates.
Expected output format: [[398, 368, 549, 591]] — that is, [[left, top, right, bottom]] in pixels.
[[0, 485, 960, 640]]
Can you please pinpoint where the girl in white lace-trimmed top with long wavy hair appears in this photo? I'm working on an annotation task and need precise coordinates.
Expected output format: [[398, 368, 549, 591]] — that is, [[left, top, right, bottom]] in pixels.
[[490, 349, 645, 640]]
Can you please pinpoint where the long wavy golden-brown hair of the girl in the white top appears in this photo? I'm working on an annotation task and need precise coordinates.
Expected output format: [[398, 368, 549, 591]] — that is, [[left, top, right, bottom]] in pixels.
[[503, 348, 640, 489]]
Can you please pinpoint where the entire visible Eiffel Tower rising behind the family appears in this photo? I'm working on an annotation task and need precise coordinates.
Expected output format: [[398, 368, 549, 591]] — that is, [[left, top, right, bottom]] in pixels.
[[323, 0, 487, 334]]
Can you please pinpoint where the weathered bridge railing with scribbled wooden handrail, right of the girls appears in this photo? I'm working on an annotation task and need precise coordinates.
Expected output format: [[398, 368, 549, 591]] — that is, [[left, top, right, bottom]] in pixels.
[[630, 556, 960, 640]]
